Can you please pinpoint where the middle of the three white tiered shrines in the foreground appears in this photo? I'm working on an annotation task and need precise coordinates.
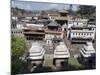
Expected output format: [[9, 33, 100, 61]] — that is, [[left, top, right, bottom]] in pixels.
[[53, 42, 70, 66]]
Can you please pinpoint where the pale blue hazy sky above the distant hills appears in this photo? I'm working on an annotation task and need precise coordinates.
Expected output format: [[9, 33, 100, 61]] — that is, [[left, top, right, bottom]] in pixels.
[[11, 0, 79, 11]]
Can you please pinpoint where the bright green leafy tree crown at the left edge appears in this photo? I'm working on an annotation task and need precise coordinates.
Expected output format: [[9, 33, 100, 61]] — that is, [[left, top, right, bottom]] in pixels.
[[11, 35, 27, 58]]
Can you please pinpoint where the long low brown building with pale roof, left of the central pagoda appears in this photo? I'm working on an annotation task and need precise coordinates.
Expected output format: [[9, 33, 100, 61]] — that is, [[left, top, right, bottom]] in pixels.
[[23, 23, 45, 40]]
